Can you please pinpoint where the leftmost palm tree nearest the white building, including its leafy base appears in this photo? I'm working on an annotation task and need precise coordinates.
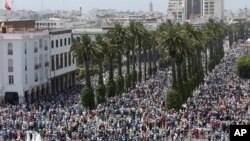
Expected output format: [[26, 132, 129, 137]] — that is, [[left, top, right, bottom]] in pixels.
[[71, 34, 95, 109]]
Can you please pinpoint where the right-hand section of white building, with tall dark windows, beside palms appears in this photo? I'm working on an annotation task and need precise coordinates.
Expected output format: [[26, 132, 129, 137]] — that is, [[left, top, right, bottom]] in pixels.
[[49, 29, 76, 93]]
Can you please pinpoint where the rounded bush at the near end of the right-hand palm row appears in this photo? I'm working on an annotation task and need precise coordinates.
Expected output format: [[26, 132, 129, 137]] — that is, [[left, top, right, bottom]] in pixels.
[[165, 89, 182, 110]]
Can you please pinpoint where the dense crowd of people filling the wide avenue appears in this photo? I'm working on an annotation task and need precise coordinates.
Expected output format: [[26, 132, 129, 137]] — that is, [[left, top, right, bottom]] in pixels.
[[0, 42, 250, 141]]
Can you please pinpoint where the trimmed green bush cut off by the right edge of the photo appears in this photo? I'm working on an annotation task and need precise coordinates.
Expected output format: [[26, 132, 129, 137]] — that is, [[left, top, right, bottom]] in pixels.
[[236, 55, 250, 79]]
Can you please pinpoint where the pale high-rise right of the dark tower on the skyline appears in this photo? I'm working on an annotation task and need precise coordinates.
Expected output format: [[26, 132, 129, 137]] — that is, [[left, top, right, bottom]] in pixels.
[[202, 0, 224, 19]]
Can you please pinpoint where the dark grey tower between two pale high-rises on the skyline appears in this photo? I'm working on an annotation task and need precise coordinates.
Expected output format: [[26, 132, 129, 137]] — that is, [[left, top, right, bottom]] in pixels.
[[185, 0, 202, 19]]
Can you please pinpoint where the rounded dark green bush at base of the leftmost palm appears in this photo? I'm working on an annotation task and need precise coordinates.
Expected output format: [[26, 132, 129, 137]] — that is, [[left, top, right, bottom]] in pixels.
[[80, 86, 95, 110]]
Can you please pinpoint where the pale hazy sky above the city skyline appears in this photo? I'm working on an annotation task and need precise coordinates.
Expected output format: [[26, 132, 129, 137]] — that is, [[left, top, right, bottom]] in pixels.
[[0, 0, 250, 12]]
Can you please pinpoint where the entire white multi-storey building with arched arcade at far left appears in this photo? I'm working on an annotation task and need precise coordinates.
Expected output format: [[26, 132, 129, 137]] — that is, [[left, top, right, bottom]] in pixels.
[[0, 21, 76, 103]]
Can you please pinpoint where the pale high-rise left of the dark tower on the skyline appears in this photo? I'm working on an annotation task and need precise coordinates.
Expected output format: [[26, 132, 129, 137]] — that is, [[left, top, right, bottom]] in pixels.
[[167, 0, 186, 20]]
